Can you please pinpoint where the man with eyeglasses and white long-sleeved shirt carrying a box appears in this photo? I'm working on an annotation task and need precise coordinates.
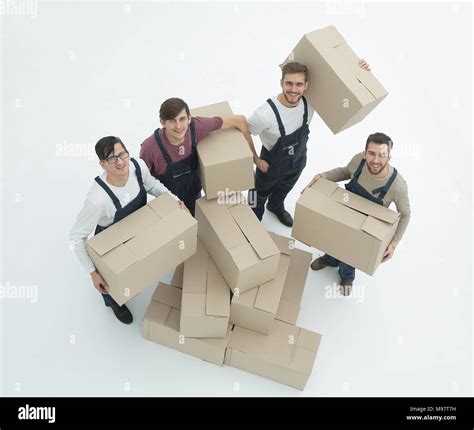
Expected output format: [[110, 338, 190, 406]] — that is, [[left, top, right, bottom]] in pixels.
[[69, 136, 186, 324]]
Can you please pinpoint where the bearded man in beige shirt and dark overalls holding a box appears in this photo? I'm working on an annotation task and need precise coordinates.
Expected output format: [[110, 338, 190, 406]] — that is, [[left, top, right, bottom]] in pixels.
[[302, 133, 410, 296]]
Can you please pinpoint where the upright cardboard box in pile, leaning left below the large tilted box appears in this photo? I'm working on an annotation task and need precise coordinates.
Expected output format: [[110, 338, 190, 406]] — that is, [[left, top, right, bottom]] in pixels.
[[180, 239, 230, 337]]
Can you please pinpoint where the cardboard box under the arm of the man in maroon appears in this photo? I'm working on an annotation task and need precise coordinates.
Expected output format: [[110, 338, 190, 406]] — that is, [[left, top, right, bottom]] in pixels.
[[191, 102, 254, 199]]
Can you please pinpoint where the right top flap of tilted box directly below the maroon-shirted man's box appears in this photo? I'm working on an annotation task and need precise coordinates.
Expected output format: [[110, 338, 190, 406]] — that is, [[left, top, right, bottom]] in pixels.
[[229, 204, 279, 259]]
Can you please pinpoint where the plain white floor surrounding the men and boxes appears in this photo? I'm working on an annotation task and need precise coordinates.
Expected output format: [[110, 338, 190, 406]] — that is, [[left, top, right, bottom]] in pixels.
[[0, 0, 473, 396]]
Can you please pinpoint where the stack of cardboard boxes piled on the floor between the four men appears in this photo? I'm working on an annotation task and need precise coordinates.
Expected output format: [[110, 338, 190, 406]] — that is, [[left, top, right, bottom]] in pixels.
[[143, 103, 321, 389]]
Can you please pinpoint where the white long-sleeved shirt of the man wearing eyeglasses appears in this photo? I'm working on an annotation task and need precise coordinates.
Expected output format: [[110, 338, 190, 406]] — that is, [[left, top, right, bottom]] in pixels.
[[69, 159, 179, 273]]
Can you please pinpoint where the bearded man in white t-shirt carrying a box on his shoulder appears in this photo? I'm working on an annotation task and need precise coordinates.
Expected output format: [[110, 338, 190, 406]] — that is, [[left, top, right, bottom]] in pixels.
[[248, 59, 370, 227]]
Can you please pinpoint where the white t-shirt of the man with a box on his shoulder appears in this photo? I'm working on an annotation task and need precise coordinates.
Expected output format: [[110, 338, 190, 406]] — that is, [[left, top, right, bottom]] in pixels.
[[248, 96, 314, 151]]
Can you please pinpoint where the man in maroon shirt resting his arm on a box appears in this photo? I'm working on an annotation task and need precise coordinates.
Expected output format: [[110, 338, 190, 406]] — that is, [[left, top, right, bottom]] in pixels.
[[140, 98, 256, 216]]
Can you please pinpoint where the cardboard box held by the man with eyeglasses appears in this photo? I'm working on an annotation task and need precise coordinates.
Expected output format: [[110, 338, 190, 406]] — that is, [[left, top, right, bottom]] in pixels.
[[86, 194, 197, 305]]
